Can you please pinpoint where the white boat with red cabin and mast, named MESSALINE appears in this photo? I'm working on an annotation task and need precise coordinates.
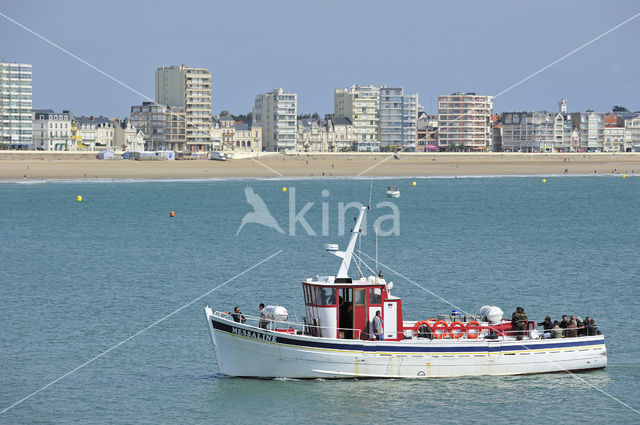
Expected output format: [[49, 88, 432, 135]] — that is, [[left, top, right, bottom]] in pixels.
[[205, 207, 607, 379]]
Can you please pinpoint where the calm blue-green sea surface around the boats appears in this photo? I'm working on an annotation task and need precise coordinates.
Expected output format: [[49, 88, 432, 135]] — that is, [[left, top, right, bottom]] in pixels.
[[0, 176, 640, 424]]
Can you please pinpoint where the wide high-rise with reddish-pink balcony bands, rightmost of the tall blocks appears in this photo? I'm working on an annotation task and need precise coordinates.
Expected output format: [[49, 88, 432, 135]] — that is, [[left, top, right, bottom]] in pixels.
[[438, 92, 493, 151]]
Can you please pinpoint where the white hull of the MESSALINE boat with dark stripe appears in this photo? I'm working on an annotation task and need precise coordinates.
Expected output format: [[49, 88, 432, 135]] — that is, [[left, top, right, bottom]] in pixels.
[[205, 307, 607, 378]]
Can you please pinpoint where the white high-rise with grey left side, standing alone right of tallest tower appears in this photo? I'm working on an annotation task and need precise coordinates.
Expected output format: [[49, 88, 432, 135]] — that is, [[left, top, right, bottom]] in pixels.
[[253, 88, 298, 152]]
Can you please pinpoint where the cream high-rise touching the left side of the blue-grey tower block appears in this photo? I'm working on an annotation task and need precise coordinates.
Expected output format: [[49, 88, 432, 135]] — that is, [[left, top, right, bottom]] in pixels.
[[333, 85, 380, 152]]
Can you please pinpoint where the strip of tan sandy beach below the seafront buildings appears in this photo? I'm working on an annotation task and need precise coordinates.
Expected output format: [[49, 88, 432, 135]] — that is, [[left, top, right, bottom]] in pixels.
[[0, 153, 640, 180]]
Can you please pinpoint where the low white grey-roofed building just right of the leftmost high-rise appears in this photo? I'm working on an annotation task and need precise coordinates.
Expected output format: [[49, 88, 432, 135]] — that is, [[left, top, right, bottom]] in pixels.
[[31, 109, 76, 151]]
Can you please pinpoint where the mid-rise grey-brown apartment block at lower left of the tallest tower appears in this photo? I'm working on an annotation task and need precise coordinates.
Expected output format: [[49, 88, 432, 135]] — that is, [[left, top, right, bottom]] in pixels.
[[130, 102, 185, 151]]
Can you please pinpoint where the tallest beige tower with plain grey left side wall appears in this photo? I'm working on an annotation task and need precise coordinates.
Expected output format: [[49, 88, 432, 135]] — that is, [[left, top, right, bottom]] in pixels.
[[155, 65, 212, 151]]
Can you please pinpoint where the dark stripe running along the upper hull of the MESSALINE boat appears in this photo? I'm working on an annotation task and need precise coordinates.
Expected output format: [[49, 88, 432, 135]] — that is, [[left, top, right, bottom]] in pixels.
[[211, 319, 604, 353]]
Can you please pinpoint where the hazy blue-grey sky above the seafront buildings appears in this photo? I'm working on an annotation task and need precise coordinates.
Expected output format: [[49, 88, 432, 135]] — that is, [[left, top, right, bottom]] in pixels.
[[0, 0, 640, 116]]
